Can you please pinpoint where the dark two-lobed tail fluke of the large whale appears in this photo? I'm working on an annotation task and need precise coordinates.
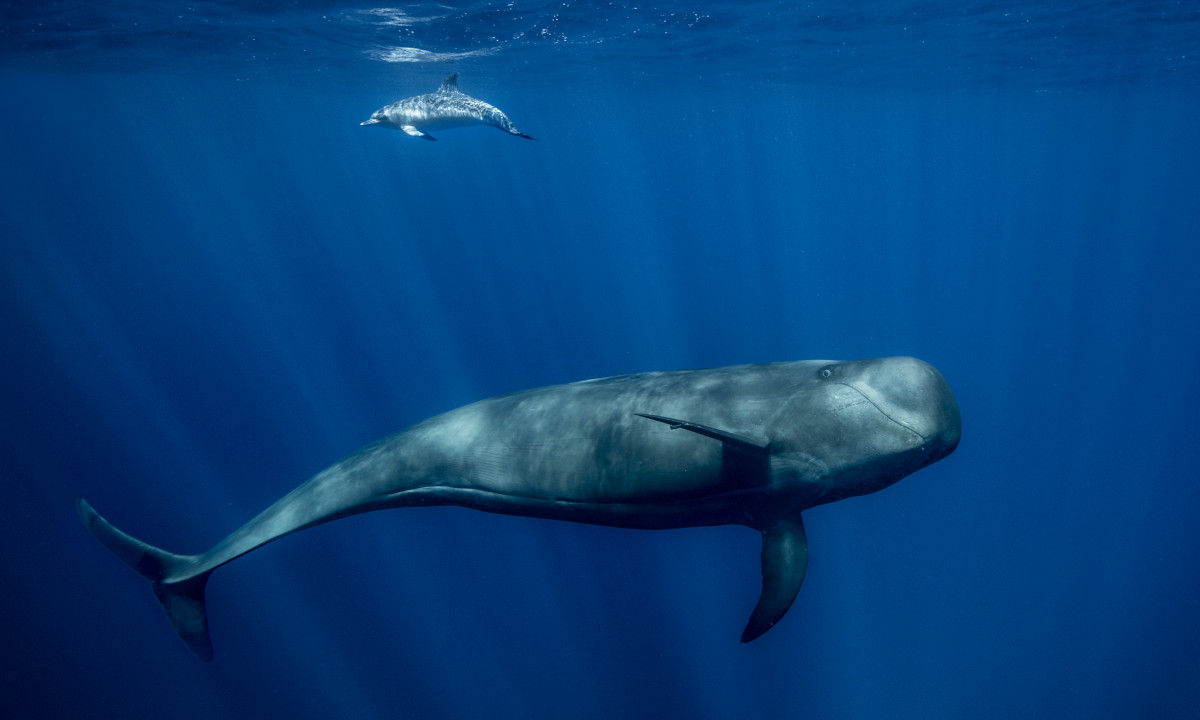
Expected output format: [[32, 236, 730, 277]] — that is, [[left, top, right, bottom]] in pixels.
[[77, 499, 212, 661]]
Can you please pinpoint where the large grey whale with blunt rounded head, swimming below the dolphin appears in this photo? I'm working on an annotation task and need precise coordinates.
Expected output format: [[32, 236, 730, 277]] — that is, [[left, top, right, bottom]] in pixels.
[[78, 358, 961, 660]]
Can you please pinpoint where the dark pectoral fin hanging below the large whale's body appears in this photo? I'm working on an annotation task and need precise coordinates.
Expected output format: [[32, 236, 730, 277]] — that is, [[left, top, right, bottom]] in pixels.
[[742, 515, 809, 642]]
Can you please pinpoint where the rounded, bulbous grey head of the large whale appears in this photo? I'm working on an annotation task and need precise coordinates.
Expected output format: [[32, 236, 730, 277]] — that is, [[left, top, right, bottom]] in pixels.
[[772, 358, 962, 505]]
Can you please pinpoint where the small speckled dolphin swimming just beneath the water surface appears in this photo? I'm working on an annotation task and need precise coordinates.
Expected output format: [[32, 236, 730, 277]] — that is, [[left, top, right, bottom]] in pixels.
[[359, 72, 534, 140]]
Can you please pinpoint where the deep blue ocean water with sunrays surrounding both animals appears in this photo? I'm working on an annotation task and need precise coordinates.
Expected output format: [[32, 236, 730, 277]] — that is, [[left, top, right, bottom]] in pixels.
[[0, 0, 1200, 720]]
